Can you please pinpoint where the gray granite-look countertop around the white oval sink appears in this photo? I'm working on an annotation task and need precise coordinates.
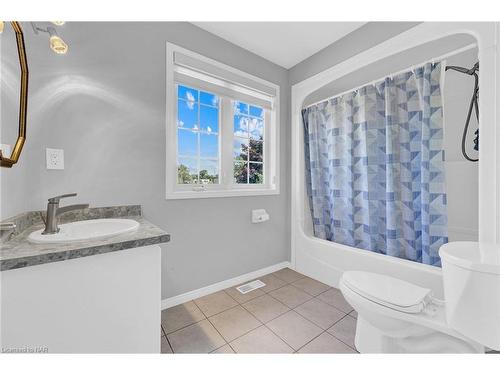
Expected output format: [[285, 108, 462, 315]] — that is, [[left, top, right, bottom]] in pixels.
[[0, 205, 170, 271]]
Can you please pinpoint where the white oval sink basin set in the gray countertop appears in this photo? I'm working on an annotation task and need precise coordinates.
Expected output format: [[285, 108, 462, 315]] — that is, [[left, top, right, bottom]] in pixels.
[[28, 219, 139, 243]]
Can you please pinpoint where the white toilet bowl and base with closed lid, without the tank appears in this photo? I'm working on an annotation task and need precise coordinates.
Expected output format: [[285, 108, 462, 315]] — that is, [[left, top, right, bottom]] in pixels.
[[339, 271, 484, 353]]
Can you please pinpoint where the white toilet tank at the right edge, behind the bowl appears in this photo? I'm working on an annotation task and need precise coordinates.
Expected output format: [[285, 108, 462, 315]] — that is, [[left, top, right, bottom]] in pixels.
[[439, 242, 500, 350]]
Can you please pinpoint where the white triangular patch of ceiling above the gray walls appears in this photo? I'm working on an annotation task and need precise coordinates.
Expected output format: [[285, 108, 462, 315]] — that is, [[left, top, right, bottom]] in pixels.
[[193, 22, 365, 69]]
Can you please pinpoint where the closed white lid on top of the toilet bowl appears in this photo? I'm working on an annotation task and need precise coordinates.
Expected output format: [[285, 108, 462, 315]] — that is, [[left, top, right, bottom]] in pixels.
[[342, 271, 432, 313]]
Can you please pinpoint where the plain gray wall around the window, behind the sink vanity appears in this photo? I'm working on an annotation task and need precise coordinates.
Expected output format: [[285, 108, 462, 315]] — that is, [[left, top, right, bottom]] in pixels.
[[2, 22, 290, 298]]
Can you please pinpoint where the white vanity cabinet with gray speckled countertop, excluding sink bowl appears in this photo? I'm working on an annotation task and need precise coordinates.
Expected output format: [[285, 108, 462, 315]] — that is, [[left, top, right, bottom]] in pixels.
[[0, 206, 170, 353]]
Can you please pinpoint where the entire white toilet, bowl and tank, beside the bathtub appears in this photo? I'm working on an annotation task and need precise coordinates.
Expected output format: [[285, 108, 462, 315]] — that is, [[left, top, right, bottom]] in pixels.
[[340, 242, 500, 353]]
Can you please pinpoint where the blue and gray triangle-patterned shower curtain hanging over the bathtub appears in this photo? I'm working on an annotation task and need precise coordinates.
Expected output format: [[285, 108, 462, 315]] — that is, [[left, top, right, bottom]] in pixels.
[[302, 63, 448, 266]]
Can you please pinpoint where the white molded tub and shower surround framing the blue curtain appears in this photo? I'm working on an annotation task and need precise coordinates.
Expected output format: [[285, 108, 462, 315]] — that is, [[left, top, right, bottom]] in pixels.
[[291, 22, 500, 298]]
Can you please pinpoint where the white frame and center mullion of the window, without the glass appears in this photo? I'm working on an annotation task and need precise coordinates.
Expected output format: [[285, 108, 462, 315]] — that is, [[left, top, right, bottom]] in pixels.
[[166, 43, 280, 199]]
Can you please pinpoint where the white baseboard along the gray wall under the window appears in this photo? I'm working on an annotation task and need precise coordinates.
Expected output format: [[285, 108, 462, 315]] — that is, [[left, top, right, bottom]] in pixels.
[[161, 262, 291, 310]]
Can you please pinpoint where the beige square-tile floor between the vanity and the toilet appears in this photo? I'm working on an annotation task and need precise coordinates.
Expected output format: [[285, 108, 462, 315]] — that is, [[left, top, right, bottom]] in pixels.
[[161, 268, 357, 353]]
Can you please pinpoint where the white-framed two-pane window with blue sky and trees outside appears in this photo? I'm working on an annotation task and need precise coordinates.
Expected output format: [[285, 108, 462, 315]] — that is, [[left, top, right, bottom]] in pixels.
[[166, 43, 279, 199]]
